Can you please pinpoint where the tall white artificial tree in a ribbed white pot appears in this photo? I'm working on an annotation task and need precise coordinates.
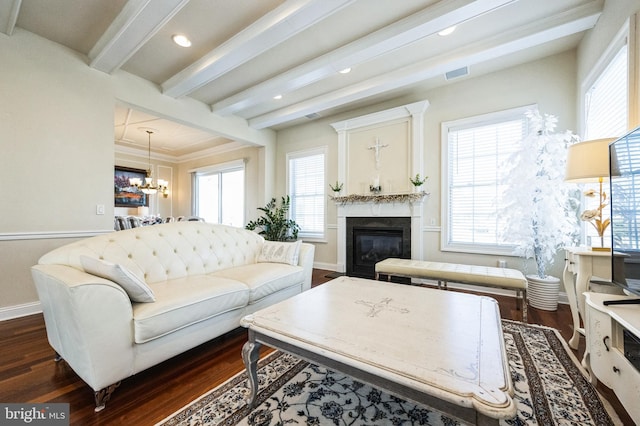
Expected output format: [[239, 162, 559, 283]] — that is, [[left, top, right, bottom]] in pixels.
[[502, 110, 577, 310]]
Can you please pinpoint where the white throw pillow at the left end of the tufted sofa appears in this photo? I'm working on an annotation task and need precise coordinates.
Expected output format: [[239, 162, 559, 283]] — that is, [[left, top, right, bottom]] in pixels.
[[80, 256, 156, 302]]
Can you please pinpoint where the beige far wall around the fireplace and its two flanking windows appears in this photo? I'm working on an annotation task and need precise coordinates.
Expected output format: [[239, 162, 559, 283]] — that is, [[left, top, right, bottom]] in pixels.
[[276, 51, 576, 276]]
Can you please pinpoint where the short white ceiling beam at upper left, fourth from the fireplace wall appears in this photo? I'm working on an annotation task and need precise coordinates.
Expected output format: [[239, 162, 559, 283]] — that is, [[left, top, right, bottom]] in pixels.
[[89, 0, 189, 74]]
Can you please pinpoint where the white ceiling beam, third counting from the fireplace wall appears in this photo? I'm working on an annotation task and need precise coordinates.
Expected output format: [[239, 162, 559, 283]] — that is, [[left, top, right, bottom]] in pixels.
[[162, 0, 355, 98]]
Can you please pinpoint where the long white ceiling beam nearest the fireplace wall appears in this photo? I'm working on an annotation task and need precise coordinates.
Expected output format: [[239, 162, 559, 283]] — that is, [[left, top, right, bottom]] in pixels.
[[249, 0, 603, 129]]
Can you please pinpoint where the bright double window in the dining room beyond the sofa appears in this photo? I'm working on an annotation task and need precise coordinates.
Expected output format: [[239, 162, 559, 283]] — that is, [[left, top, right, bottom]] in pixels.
[[191, 160, 245, 227]]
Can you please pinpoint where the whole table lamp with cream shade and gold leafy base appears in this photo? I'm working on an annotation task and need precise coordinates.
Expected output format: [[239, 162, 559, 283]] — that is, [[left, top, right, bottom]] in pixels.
[[564, 138, 615, 251]]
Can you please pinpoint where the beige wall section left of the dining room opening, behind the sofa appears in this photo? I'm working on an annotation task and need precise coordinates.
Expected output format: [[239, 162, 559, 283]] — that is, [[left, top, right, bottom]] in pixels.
[[0, 30, 114, 308]]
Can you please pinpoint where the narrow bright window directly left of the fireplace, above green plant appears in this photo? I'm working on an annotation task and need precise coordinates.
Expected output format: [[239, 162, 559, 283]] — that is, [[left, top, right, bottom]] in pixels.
[[287, 148, 326, 239]]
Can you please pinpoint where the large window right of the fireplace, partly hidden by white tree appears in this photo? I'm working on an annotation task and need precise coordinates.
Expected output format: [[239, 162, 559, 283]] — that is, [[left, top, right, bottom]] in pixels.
[[442, 107, 531, 254]]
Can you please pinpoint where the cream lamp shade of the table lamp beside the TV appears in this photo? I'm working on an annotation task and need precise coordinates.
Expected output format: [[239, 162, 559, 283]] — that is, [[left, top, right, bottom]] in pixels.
[[564, 138, 615, 183]]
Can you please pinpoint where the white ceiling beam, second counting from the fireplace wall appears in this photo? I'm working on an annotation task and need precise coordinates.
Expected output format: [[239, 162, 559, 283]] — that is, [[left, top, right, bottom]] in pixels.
[[211, 0, 516, 116]]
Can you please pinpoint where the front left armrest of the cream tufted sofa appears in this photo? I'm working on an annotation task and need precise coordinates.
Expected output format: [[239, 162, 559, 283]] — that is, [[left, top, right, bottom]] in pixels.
[[31, 265, 134, 390]]
